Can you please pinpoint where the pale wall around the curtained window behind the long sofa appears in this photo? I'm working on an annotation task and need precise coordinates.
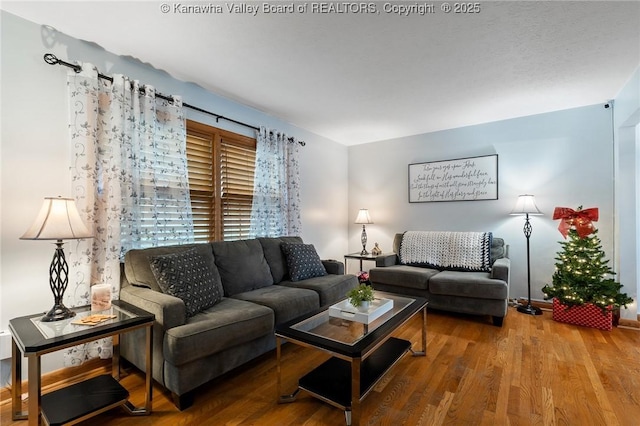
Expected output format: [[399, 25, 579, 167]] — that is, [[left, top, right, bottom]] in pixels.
[[0, 12, 347, 371]]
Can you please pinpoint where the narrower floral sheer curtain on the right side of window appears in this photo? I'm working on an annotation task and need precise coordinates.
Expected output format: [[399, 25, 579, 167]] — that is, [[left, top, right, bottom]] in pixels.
[[250, 127, 301, 237]]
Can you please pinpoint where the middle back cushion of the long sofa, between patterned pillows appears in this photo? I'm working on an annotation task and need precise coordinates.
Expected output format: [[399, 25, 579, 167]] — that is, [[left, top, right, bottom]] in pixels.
[[211, 240, 273, 296]]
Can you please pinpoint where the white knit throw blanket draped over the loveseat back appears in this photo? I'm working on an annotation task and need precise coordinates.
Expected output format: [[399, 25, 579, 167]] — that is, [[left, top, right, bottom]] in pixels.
[[399, 231, 492, 271]]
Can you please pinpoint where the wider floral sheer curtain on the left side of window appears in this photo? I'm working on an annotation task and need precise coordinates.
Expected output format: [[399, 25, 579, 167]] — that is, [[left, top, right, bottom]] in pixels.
[[65, 63, 193, 365]]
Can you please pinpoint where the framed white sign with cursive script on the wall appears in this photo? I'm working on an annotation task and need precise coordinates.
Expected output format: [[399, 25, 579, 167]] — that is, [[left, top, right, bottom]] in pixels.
[[409, 154, 498, 203]]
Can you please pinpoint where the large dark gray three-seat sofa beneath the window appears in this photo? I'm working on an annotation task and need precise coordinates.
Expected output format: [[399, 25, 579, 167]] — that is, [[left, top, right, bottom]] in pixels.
[[120, 237, 358, 409]]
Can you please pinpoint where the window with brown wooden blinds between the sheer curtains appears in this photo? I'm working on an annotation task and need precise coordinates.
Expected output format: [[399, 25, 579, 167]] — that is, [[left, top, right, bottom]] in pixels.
[[187, 120, 256, 242]]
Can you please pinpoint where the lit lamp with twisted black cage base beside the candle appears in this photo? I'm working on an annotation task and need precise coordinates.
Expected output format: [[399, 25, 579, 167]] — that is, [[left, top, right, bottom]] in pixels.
[[20, 197, 92, 322]]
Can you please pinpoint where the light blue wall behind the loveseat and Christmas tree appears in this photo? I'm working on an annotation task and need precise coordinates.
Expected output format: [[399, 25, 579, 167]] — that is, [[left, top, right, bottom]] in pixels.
[[349, 104, 635, 312]]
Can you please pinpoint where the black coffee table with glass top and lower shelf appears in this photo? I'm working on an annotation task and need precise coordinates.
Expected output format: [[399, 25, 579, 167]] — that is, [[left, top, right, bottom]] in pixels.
[[276, 291, 428, 426]]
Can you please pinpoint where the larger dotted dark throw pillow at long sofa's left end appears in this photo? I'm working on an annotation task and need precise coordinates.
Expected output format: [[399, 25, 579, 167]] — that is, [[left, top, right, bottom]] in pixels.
[[150, 249, 223, 317]]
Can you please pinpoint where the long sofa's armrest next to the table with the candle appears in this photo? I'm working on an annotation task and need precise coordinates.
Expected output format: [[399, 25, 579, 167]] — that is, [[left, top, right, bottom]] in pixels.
[[120, 285, 187, 330]]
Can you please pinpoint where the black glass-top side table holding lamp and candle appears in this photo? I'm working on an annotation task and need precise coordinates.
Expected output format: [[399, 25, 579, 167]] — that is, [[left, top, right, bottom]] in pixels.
[[9, 301, 155, 426]]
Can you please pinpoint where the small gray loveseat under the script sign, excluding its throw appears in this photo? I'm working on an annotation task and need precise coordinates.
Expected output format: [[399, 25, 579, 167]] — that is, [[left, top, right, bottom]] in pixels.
[[369, 233, 510, 326]]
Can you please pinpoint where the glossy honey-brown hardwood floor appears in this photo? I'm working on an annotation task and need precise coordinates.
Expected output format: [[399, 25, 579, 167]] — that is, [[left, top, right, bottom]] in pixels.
[[0, 308, 640, 426]]
